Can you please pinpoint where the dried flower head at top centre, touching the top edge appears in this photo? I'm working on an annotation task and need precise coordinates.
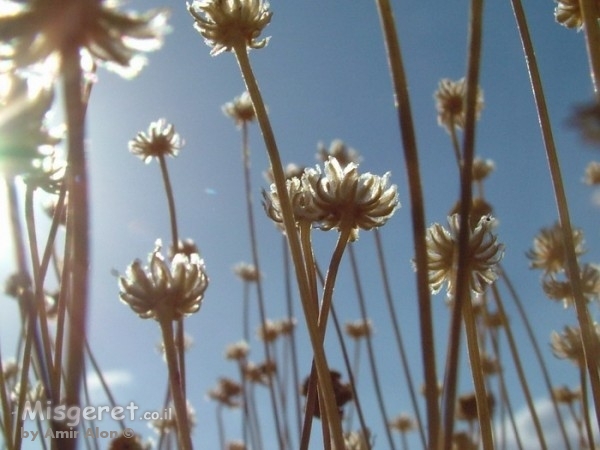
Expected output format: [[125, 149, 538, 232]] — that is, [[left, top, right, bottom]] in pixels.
[[187, 0, 273, 56]]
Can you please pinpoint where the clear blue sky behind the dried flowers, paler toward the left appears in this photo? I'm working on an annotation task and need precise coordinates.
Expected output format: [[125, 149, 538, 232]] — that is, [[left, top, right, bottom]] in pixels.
[[0, 0, 600, 449]]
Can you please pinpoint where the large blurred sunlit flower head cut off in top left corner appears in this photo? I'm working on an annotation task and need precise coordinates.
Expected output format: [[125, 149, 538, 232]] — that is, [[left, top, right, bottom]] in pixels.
[[0, 0, 169, 77]]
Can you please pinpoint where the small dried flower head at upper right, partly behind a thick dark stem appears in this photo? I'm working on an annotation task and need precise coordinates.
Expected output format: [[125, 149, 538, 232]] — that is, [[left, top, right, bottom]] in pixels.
[[434, 78, 483, 131]]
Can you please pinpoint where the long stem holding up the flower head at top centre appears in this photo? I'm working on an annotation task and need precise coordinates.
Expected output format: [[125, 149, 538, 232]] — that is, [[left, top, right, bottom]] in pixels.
[[233, 41, 344, 448]]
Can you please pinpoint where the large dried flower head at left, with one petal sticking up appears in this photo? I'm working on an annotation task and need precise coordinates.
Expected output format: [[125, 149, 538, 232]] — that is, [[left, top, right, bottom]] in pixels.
[[119, 242, 208, 320]]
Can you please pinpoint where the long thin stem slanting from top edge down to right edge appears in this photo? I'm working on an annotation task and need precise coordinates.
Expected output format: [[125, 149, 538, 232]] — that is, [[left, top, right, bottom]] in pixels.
[[511, 0, 600, 432]]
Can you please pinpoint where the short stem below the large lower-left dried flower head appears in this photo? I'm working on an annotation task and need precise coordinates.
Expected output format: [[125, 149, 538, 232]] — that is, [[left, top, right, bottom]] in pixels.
[[158, 316, 193, 450]]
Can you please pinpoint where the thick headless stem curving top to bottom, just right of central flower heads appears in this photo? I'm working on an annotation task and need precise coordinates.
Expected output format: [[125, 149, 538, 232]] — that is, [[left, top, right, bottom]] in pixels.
[[376, 0, 440, 449]]
